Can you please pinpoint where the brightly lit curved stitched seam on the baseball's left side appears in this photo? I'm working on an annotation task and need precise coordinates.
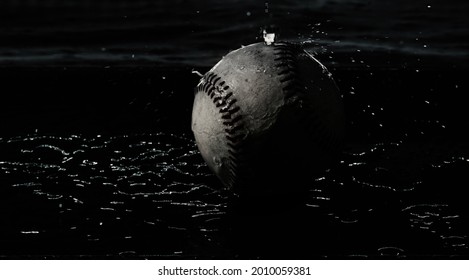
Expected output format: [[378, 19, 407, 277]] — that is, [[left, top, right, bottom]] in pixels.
[[196, 72, 245, 188]]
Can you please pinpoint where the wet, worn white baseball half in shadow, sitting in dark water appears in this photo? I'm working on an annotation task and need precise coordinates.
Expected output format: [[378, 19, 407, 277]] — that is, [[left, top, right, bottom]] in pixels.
[[192, 42, 344, 194]]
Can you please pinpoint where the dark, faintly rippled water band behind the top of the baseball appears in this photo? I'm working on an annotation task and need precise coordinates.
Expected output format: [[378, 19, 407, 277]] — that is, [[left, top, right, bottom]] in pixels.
[[0, 0, 469, 67]]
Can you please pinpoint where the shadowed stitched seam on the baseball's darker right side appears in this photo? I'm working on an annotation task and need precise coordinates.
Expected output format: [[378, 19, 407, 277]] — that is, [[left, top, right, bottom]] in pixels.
[[274, 42, 339, 150]]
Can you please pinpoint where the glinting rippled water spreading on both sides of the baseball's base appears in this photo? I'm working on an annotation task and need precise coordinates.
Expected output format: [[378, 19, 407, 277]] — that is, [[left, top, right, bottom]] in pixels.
[[0, 127, 469, 258]]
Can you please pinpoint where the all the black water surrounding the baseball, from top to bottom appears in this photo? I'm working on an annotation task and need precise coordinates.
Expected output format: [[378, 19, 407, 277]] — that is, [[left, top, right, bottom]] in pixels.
[[0, 0, 469, 259]]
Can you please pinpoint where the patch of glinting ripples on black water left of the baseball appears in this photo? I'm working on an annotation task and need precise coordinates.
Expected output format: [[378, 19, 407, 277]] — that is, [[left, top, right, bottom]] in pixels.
[[0, 134, 226, 255]]
